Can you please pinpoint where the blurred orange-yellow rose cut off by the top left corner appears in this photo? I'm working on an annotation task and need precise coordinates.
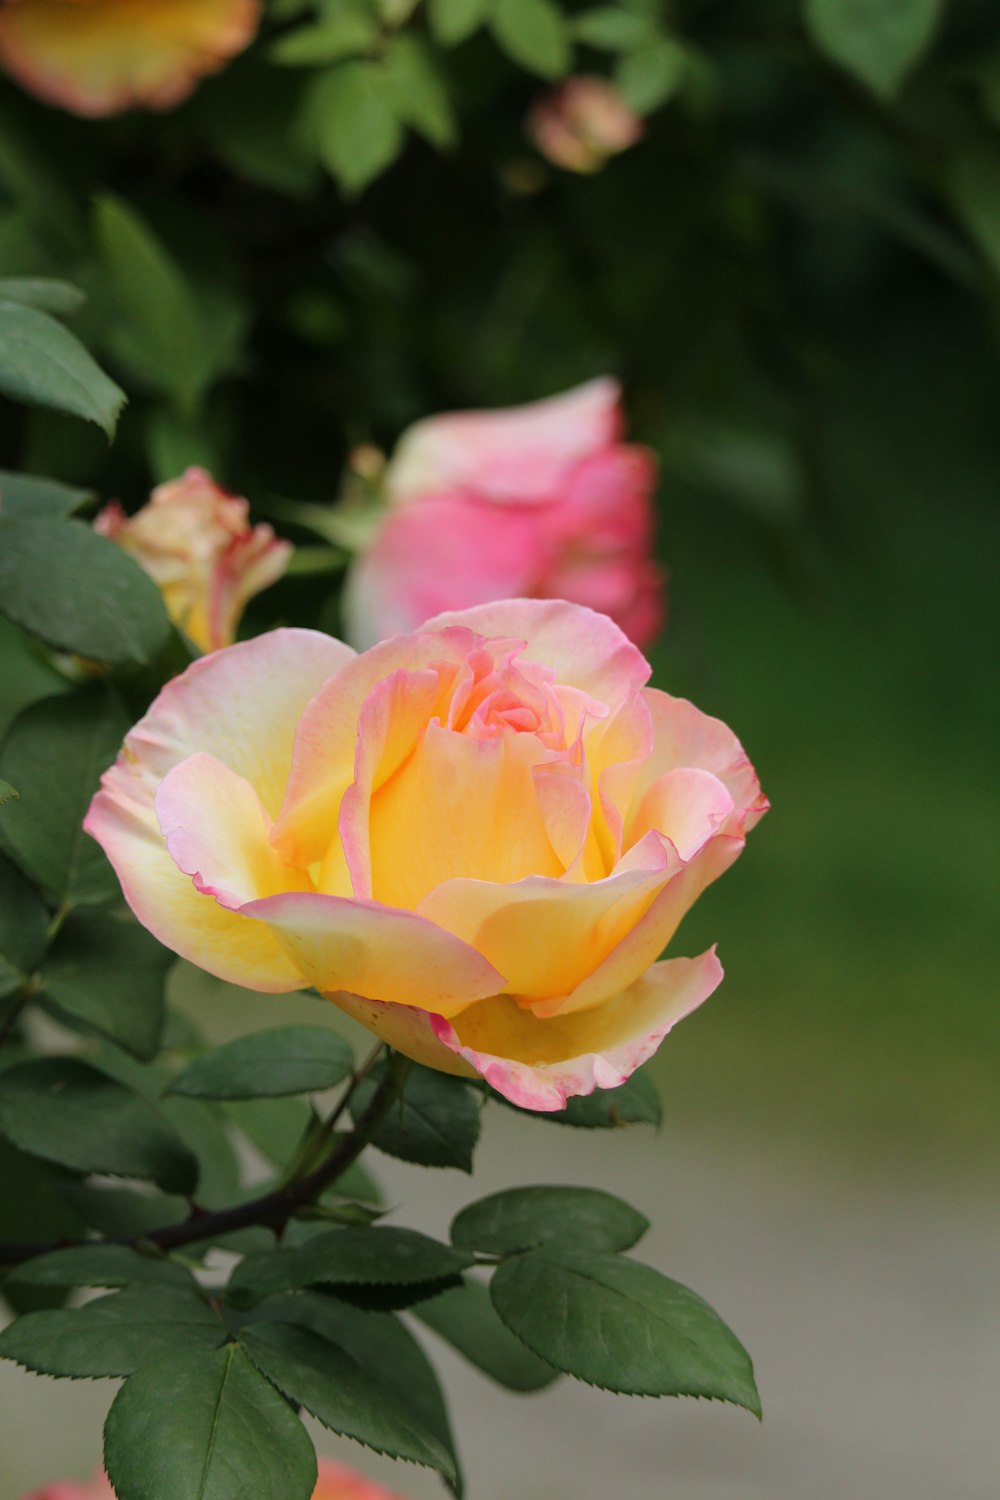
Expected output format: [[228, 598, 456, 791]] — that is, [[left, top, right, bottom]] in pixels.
[[0, 0, 261, 116]]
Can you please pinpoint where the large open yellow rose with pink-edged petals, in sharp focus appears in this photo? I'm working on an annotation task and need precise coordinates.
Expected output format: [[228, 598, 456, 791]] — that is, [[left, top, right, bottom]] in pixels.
[[84, 600, 766, 1110]]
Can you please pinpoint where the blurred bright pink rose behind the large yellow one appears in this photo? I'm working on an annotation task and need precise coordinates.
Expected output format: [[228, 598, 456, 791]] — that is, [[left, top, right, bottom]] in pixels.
[[345, 378, 663, 647]]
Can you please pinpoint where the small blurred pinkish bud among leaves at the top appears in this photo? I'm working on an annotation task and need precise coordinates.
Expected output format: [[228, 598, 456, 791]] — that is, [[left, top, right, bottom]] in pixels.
[[526, 75, 645, 173]]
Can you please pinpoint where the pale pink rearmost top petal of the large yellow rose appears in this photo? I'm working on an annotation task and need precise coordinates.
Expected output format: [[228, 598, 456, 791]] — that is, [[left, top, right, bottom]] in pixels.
[[421, 599, 652, 710]]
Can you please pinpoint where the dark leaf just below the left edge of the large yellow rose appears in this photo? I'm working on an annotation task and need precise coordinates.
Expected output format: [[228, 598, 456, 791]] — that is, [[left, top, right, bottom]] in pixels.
[[42, 914, 175, 1061]]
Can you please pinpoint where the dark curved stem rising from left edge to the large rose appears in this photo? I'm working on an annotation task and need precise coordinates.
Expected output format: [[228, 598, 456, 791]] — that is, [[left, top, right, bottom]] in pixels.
[[0, 1049, 409, 1266]]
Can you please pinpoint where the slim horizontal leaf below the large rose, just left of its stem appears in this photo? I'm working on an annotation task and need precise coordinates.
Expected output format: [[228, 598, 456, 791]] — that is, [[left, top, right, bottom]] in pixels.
[[169, 1026, 354, 1100]]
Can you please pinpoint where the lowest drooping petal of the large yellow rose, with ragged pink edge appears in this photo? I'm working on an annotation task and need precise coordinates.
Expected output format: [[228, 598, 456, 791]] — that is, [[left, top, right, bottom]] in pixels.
[[430, 948, 723, 1112]]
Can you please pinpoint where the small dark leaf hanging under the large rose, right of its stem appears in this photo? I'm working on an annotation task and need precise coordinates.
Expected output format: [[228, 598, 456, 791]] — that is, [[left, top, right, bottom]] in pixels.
[[351, 1064, 480, 1172]]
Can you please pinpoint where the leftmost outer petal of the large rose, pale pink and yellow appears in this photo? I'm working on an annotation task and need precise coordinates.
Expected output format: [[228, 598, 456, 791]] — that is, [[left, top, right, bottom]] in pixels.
[[84, 630, 354, 992]]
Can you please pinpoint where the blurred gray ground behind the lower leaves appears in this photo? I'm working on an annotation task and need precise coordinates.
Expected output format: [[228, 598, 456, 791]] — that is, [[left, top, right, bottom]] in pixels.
[[0, 1110, 1000, 1500]]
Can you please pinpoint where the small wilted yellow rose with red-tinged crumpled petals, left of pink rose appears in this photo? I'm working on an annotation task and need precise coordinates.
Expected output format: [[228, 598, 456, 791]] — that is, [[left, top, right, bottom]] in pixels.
[[94, 468, 292, 651]]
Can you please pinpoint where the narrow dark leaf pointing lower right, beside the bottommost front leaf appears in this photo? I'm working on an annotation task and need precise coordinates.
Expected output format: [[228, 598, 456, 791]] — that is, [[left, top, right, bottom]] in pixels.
[[240, 1323, 457, 1482]]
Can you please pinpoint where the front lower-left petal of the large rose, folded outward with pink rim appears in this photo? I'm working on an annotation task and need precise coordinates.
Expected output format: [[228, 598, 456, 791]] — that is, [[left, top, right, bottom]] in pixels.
[[240, 893, 507, 1016]]
